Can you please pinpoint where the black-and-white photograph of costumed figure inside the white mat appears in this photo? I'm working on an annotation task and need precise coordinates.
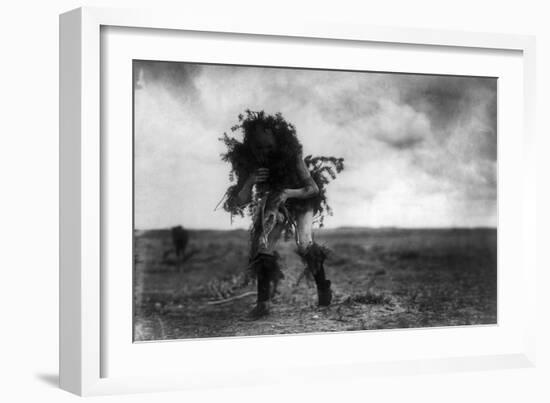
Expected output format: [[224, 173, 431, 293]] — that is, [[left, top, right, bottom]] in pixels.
[[132, 60, 498, 342]]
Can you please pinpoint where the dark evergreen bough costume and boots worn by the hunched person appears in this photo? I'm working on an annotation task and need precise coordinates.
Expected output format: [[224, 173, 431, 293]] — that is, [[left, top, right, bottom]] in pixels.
[[220, 110, 344, 317]]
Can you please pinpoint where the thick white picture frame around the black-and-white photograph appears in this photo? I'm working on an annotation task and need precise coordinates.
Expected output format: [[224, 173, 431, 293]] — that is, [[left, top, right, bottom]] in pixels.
[[60, 8, 537, 395]]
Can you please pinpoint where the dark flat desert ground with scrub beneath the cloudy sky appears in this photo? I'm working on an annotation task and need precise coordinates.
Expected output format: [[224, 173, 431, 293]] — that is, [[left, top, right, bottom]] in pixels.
[[133, 228, 497, 341]]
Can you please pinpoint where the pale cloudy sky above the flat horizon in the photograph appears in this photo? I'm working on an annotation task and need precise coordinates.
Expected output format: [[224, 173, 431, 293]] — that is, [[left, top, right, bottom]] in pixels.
[[134, 61, 497, 229]]
